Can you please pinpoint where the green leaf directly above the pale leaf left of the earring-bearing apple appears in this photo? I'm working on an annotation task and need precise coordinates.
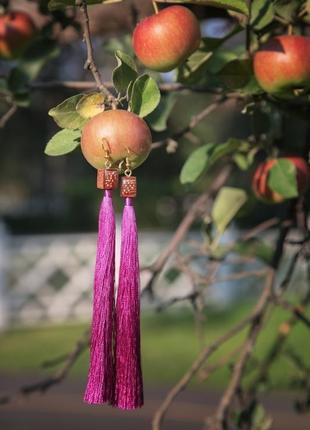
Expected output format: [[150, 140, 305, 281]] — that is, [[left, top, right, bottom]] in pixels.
[[48, 94, 86, 130]]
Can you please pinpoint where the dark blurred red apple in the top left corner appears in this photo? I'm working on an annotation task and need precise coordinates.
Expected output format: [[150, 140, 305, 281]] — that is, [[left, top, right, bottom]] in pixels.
[[0, 11, 36, 59]]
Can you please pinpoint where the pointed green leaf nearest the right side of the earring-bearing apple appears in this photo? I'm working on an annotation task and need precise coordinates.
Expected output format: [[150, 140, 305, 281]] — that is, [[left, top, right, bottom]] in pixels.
[[180, 143, 214, 184]]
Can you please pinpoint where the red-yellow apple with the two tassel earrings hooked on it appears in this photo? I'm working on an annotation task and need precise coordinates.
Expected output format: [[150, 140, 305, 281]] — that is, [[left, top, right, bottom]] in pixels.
[[81, 110, 152, 169]]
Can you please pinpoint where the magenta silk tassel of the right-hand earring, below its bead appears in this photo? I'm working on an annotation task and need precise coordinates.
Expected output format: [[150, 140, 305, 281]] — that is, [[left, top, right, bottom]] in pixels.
[[114, 198, 143, 409]]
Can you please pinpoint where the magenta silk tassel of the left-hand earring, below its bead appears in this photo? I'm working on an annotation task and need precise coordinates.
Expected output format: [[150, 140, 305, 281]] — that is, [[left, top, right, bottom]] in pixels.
[[84, 191, 115, 404]]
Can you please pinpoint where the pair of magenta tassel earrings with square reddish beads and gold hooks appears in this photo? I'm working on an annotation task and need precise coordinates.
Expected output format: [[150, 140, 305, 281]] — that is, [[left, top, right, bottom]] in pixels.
[[84, 155, 143, 409]]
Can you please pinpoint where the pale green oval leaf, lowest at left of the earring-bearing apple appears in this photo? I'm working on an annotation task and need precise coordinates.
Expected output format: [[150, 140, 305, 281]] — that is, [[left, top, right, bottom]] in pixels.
[[44, 129, 81, 157]]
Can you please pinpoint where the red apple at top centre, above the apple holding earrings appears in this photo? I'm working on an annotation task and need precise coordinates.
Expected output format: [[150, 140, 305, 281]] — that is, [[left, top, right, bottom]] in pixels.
[[133, 6, 201, 72]]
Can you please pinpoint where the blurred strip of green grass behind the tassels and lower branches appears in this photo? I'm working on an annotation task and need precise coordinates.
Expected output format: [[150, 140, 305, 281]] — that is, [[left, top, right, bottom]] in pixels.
[[0, 304, 310, 388]]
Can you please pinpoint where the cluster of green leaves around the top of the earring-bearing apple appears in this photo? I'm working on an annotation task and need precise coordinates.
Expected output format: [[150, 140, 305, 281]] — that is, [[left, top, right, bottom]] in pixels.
[[45, 50, 166, 156]]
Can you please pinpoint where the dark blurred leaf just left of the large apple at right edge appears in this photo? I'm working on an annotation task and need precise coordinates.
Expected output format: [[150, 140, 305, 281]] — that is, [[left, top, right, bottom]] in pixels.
[[218, 59, 253, 89]]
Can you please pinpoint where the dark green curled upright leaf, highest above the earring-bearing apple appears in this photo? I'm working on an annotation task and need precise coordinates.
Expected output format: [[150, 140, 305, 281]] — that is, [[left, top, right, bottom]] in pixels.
[[112, 50, 138, 94]]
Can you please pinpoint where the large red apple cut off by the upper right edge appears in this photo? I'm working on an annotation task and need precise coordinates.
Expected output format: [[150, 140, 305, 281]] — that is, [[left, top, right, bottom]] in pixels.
[[254, 35, 310, 93]]
